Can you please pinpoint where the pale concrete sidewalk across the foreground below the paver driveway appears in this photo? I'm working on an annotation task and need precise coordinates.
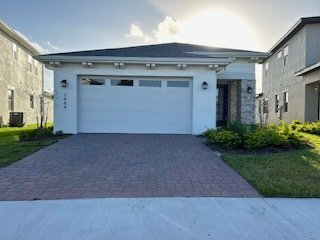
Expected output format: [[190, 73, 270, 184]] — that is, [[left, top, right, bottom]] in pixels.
[[0, 198, 320, 240]]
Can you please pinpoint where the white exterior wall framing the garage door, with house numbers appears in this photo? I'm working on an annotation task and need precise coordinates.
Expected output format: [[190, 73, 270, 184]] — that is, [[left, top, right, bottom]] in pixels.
[[54, 63, 216, 134]]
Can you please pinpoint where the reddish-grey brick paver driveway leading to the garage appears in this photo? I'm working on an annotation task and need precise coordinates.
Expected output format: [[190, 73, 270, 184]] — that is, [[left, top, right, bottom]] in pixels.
[[0, 134, 259, 200]]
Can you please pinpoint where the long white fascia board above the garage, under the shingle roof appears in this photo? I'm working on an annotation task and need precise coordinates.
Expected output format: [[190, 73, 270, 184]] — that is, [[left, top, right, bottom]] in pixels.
[[35, 55, 234, 65]]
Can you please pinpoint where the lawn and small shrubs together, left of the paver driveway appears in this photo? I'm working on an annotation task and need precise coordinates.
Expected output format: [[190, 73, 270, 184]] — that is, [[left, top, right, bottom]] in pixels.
[[0, 125, 65, 167]]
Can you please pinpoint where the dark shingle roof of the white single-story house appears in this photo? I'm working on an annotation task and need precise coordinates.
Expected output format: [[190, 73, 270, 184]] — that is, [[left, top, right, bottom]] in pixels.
[[42, 43, 264, 58]]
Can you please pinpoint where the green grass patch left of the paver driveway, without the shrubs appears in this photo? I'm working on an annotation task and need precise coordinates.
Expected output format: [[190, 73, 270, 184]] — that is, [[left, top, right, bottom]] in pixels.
[[0, 125, 57, 167]]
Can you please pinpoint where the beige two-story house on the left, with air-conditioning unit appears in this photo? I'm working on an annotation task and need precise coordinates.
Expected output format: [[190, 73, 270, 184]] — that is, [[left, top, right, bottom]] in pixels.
[[0, 21, 49, 127]]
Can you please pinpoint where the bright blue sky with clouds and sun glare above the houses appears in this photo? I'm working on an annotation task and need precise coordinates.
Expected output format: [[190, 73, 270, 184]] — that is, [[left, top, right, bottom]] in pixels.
[[0, 0, 320, 91]]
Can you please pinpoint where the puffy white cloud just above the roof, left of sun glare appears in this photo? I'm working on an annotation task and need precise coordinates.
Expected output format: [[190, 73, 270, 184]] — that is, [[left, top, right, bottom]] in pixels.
[[125, 16, 180, 42]]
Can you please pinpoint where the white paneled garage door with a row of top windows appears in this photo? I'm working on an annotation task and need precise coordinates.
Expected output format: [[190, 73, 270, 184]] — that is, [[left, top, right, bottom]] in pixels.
[[78, 77, 192, 134]]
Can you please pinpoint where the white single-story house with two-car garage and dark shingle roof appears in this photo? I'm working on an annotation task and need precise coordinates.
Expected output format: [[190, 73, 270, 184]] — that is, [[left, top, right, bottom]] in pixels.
[[36, 43, 267, 134]]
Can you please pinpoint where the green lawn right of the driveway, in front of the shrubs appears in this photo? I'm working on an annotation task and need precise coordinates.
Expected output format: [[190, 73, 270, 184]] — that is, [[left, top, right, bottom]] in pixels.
[[223, 134, 320, 197]]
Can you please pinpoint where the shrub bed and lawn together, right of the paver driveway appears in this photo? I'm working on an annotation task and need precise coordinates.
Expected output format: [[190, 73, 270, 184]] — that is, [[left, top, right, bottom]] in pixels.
[[204, 123, 320, 197]]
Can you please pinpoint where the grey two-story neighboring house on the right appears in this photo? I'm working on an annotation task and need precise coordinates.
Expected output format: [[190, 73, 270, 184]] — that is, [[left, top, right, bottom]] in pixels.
[[257, 17, 320, 123]]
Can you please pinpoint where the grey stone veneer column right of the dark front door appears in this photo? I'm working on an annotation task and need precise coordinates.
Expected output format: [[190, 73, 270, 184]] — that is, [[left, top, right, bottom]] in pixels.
[[238, 79, 256, 124]]
